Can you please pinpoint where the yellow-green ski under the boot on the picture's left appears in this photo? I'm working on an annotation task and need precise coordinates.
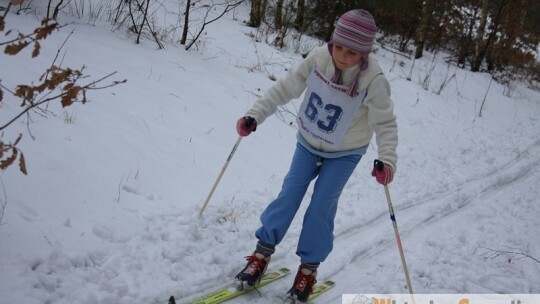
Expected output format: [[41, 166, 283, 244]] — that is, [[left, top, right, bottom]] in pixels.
[[169, 267, 291, 304]]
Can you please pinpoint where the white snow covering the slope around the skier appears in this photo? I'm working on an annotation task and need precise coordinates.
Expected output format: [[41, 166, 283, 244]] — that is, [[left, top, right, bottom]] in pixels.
[[0, 4, 540, 304]]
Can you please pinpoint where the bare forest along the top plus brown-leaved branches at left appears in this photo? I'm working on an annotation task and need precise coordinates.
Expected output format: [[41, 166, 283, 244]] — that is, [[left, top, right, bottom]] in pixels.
[[4, 0, 540, 166]]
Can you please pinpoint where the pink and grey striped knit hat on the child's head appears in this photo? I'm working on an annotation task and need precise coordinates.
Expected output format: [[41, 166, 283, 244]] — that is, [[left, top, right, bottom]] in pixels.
[[328, 9, 377, 54]]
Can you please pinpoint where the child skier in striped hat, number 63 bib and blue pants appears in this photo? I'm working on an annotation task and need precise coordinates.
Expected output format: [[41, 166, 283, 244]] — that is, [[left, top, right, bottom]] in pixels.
[[235, 10, 398, 302]]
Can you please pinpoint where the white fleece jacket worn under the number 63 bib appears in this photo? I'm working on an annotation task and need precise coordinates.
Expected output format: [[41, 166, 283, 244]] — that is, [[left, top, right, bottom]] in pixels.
[[246, 45, 398, 172]]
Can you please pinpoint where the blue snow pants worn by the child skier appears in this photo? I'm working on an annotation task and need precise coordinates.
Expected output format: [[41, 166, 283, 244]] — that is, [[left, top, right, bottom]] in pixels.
[[255, 143, 362, 263]]
